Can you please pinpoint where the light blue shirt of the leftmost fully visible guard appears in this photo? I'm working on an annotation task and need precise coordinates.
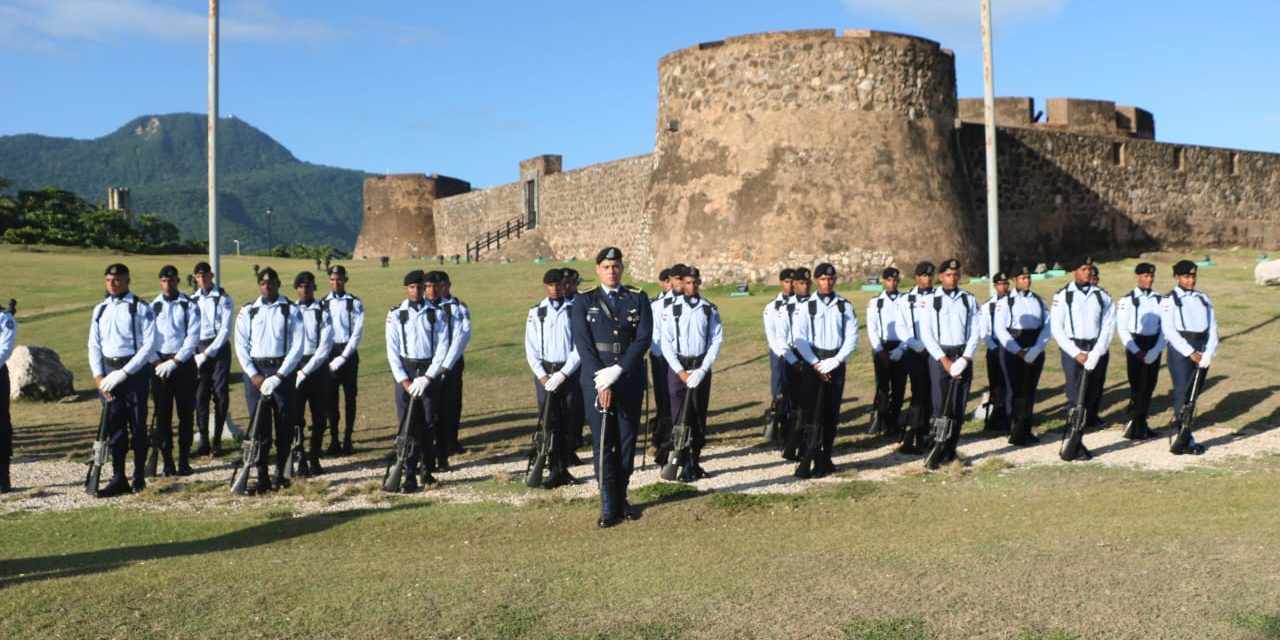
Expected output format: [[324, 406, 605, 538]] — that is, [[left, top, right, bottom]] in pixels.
[[88, 292, 156, 376]]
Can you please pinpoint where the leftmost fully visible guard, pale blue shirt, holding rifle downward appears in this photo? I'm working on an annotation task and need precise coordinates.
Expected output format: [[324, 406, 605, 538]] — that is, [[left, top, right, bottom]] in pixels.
[[88, 262, 155, 498]]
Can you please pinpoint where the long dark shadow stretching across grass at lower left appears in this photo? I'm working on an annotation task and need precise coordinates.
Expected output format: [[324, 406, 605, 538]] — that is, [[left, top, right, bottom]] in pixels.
[[0, 503, 430, 589]]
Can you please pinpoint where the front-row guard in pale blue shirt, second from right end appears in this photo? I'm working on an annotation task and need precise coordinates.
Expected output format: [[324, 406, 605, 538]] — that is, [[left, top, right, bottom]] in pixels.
[[1050, 260, 1116, 458]]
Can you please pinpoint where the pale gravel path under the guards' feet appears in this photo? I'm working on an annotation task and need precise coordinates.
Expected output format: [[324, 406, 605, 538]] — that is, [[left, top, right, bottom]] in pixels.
[[0, 425, 1280, 515]]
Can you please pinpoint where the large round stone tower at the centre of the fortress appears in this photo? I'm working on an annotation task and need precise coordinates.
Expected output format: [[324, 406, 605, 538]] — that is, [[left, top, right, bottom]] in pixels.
[[636, 31, 980, 282]]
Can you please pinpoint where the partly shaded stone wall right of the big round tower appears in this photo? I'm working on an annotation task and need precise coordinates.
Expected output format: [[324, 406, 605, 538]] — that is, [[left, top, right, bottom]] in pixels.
[[959, 124, 1280, 261]]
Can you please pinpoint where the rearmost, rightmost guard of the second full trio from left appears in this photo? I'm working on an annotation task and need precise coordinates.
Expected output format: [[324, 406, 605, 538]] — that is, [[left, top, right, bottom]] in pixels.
[[322, 265, 365, 456]]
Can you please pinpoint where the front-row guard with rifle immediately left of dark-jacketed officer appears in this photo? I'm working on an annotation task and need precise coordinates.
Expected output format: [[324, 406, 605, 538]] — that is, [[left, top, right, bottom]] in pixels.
[[525, 269, 582, 489]]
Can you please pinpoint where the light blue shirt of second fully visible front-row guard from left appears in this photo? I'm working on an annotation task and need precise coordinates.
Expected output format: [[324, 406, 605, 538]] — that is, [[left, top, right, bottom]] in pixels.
[[236, 296, 302, 378]]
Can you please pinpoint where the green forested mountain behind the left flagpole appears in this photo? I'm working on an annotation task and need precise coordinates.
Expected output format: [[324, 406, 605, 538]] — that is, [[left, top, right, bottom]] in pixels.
[[0, 114, 367, 252]]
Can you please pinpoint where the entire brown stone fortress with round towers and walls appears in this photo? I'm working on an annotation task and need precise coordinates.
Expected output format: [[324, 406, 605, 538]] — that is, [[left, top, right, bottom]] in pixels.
[[355, 29, 1280, 282]]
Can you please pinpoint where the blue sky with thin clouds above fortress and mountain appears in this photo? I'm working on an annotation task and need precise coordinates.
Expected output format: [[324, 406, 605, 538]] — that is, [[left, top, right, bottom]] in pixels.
[[0, 0, 1280, 187]]
